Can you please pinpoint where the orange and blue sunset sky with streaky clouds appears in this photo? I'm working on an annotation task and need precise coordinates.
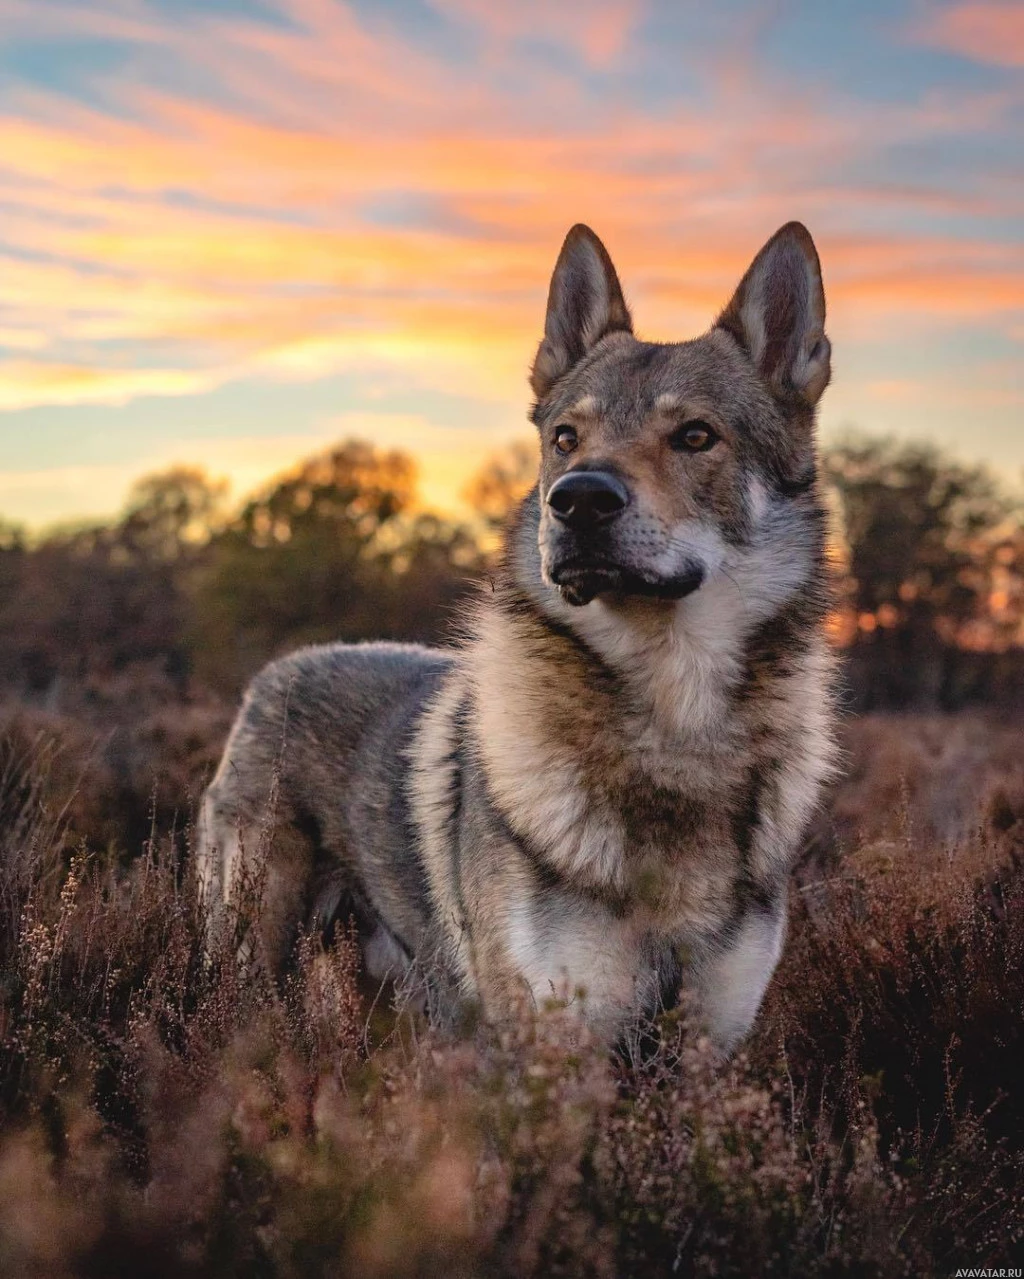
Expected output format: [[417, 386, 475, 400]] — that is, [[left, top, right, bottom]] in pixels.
[[0, 0, 1024, 527]]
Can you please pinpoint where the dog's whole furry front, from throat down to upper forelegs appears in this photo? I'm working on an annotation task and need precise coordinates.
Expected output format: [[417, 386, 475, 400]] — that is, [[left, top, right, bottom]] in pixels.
[[412, 585, 832, 1040]]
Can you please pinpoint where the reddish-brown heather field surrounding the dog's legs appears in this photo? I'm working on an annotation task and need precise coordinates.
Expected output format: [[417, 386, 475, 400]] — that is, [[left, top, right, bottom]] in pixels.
[[0, 696, 1024, 1276]]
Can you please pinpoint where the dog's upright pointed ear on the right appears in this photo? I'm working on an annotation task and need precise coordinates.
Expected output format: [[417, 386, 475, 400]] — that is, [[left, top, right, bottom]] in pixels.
[[717, 223, 832, 407]]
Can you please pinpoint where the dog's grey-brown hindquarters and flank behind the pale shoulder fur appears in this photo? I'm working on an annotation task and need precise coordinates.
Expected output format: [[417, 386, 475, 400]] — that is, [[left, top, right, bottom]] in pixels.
[[198, 643, 453, 969]]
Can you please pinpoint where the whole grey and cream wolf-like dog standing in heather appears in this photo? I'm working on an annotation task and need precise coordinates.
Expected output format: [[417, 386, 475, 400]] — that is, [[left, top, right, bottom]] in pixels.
[[197, 223, 835, 1053]]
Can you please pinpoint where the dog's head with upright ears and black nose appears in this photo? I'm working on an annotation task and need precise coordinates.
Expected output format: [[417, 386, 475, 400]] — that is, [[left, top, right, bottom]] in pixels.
[[531, 223, 830, 605]]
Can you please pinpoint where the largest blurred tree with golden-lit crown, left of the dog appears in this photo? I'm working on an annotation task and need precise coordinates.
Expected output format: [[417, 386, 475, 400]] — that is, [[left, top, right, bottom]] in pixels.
[[194, 441, 474, 680]]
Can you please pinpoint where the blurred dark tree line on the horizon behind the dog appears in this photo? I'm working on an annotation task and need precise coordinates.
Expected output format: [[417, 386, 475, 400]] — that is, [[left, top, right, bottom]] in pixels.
[[0, 437, 1024, 709]]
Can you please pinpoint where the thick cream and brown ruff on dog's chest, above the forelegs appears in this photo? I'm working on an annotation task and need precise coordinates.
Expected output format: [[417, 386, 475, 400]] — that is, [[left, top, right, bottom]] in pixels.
[[468, 593, 831, 934]]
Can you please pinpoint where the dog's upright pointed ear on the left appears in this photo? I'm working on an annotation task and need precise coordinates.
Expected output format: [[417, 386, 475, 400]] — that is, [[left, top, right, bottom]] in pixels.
[[529, 223, 633, 399]]
